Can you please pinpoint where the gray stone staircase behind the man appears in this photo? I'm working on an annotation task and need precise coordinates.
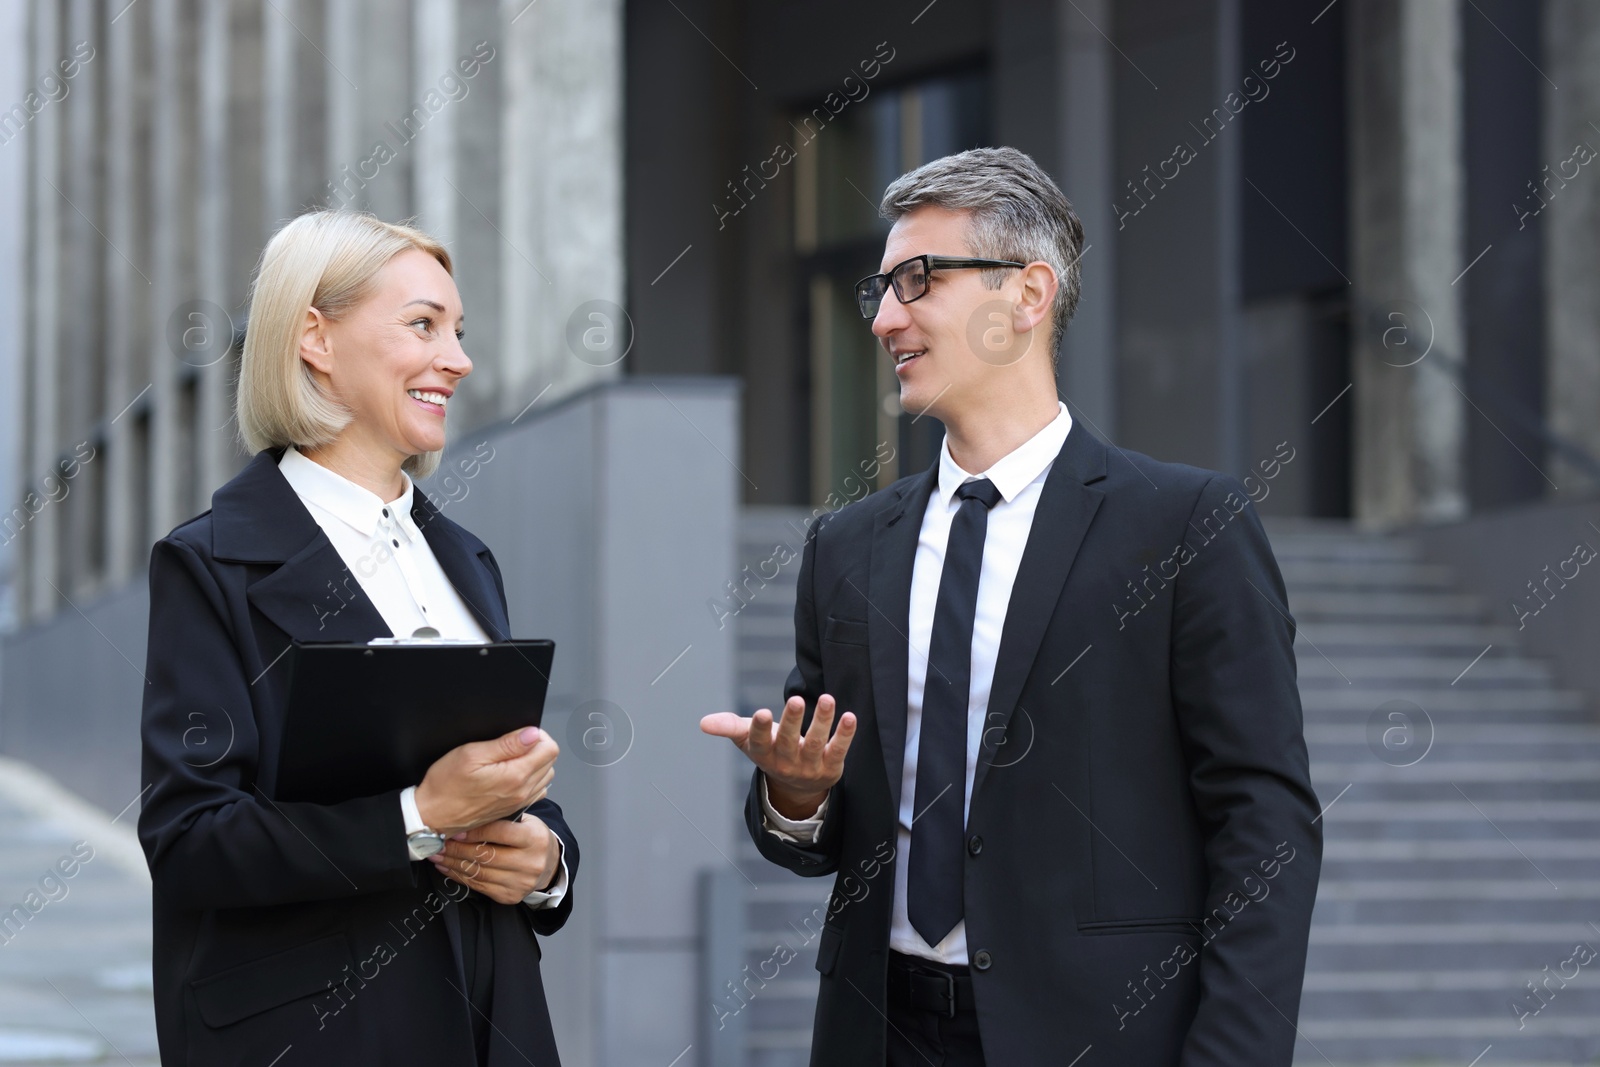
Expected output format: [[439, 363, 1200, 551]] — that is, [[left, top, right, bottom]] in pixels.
[[734, 509, 1600, 1067]]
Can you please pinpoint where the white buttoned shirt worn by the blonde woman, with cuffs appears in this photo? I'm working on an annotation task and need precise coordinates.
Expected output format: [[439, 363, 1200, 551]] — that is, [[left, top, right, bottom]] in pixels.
[[278, 446, 566, 907]]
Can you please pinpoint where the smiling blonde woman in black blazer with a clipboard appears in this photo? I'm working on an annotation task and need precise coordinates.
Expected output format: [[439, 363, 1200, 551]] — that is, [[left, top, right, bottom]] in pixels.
[[139, 211, 578, 1067]]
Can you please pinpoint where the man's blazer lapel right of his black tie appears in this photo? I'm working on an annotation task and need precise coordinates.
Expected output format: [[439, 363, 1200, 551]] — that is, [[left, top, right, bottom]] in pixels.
[[973, 422, 1106, 797]]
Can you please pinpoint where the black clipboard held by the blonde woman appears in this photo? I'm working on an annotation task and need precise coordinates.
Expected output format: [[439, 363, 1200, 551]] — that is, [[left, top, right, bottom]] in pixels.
[[274, 640, 555, 805]]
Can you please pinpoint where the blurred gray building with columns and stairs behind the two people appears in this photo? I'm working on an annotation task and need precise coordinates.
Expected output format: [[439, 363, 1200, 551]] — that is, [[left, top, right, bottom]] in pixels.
[[0, 0, 1600, 1064]]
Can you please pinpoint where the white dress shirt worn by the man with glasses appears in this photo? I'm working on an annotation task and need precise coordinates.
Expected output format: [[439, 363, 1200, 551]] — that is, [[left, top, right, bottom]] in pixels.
[[762, 402, 1072, 963]]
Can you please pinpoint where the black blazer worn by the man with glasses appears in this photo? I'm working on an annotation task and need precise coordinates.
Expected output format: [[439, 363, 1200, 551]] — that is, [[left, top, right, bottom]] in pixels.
[[746, 424, 1322, 1067]]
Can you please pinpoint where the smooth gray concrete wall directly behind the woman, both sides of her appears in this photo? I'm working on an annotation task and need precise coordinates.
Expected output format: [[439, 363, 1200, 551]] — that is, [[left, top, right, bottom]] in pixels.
[[0, 378, 741, 1067]]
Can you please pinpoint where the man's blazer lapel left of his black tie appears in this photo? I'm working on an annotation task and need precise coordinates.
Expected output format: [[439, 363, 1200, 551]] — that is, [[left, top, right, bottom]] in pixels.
[[867, 462, 939, 811]]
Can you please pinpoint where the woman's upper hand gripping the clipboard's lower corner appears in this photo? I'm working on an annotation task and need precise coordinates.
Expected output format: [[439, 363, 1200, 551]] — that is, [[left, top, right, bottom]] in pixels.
[[416, 726, 560, 835]]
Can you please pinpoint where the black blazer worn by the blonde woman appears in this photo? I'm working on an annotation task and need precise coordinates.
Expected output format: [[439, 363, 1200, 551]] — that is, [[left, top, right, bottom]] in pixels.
[[139, 451, 578, 1067]]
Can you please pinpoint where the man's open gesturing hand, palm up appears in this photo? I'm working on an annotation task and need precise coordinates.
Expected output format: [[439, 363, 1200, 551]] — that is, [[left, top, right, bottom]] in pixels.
[[701, 693, 856, 819]]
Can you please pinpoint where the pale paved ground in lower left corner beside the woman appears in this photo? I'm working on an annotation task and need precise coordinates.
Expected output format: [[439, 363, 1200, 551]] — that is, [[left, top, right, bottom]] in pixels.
[[0, 758, 158, 1067]]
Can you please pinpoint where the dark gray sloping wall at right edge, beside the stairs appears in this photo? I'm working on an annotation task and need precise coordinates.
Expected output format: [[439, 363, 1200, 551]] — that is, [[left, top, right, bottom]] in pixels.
[[1414, 498, 1600, 710]]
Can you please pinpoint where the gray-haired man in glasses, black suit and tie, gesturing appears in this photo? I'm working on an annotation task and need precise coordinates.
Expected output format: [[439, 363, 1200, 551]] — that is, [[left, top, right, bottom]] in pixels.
[[702, 149, 1322, 1067]]
